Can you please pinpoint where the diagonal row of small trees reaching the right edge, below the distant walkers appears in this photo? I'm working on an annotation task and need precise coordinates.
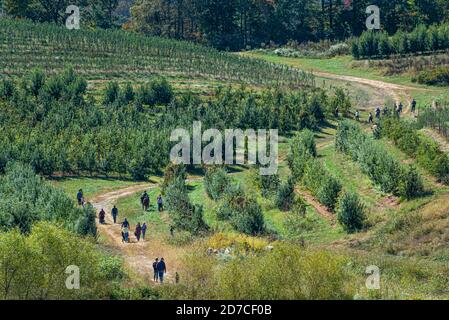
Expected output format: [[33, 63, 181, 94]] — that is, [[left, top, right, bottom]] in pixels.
[[380, 117, 449, 185]]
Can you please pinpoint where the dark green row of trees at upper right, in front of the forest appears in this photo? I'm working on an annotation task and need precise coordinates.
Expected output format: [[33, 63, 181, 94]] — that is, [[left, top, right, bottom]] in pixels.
[[352, 23, 449, 59]]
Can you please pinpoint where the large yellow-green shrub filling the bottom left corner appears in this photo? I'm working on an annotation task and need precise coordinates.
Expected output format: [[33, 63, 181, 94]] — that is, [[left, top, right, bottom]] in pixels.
[[0, 222, 115, 300]]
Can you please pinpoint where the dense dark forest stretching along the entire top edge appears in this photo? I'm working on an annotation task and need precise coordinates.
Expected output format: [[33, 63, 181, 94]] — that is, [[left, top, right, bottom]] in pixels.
[[1, 0, 449, 50]]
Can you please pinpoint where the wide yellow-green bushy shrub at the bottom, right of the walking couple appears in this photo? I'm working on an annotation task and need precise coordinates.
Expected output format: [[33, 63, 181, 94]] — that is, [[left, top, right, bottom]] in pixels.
[[215, 244, 353, 300]]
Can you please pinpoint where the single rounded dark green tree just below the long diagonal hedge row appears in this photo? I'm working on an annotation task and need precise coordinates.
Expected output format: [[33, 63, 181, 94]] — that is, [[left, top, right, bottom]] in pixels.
[[337, 192, 365, 233]]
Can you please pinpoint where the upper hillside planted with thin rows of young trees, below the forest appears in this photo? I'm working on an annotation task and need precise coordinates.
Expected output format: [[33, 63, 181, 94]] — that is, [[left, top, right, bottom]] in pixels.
[[0, 19, 312, 86]]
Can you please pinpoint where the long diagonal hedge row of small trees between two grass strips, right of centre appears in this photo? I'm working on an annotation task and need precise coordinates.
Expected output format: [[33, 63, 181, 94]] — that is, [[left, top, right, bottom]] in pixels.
[[335, 120, 424, 199]]
